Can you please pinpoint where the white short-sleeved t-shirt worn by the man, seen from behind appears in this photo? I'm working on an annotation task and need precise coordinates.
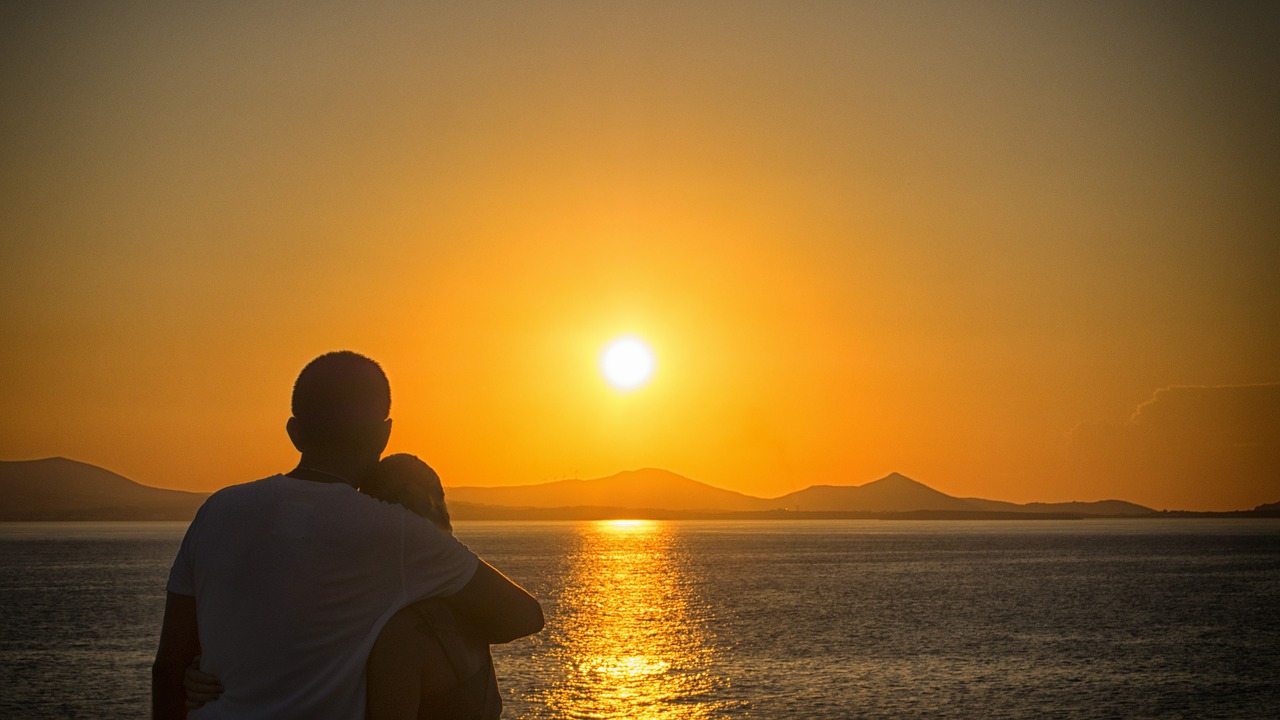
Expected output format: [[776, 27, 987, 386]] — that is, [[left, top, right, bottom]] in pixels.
[[168, 475, 479, 720]]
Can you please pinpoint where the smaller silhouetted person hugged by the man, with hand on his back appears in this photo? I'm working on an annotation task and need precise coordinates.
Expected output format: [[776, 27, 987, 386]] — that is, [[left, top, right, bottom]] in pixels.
[[184, 455, 502, 720]]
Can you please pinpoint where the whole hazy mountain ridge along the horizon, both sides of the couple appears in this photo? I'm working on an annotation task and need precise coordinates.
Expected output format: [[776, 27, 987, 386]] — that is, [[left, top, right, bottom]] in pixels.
[[0, 457, 1259, 520]]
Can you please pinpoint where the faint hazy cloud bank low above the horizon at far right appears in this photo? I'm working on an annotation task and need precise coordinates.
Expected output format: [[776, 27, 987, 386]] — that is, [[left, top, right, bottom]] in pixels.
[[1068, 383, 1280, 510]]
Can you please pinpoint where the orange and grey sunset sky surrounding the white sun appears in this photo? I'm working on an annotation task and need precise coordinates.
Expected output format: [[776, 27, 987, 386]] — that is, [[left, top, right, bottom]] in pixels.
[[0, 1, 1280, 510]]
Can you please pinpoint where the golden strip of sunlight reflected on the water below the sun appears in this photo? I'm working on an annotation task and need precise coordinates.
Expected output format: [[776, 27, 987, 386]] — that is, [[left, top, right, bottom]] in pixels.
[[527, 520, 724, 720]]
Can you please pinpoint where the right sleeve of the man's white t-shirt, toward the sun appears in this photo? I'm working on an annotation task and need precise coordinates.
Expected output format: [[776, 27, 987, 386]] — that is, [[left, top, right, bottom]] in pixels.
[[401, 510, 480, 602]]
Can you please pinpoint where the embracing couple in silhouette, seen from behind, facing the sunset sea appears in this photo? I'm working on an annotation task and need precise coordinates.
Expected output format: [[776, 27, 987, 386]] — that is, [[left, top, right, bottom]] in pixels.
[[152, 352, 543, 720]]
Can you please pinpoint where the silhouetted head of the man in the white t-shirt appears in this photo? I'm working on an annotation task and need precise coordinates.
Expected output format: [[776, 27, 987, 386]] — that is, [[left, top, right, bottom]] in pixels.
[[288, 350, 392, 464]]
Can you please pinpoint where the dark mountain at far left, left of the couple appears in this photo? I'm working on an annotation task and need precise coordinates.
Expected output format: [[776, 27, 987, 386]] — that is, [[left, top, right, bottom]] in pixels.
[[0, 457, 209, 520]]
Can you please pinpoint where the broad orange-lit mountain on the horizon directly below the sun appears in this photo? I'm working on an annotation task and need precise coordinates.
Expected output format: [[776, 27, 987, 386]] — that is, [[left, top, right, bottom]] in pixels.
[[445, 468, 778, 512]]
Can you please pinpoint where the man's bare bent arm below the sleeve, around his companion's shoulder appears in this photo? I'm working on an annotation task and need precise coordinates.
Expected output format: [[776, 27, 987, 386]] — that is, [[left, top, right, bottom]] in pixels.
[[444, 560, 544, 644]]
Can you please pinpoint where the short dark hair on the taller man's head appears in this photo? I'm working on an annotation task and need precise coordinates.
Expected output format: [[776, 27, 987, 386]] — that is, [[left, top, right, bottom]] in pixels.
[[292, 350, 392, 439]]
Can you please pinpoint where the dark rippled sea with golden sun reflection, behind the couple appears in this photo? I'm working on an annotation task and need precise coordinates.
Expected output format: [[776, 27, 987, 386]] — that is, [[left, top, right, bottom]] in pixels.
[[0, 519, 1280, 720]]
